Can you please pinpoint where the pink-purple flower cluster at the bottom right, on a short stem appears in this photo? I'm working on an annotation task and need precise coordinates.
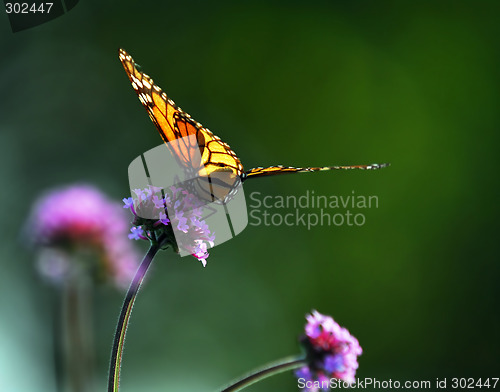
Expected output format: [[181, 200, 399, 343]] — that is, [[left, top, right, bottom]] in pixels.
[[295, 310, 363, 392]]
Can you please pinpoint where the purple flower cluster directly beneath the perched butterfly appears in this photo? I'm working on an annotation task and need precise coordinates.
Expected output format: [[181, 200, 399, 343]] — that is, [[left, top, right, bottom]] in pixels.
[[123, 185, 215, 267]]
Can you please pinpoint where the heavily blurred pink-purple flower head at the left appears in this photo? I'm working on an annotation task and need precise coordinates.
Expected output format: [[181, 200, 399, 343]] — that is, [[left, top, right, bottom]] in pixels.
[[26, 185, 140, 288]]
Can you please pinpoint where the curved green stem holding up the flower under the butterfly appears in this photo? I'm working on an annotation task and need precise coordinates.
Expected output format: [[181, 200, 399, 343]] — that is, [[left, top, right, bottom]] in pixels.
[[108, 234, 165, 392]]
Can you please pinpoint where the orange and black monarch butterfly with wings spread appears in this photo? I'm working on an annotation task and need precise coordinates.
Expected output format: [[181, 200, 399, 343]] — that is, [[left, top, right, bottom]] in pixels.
[[119, 49, 389, 200]]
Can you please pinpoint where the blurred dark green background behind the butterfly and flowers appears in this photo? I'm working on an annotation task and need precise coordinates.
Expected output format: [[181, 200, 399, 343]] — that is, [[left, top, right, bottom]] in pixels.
[[0, 0, 500, 392]]
